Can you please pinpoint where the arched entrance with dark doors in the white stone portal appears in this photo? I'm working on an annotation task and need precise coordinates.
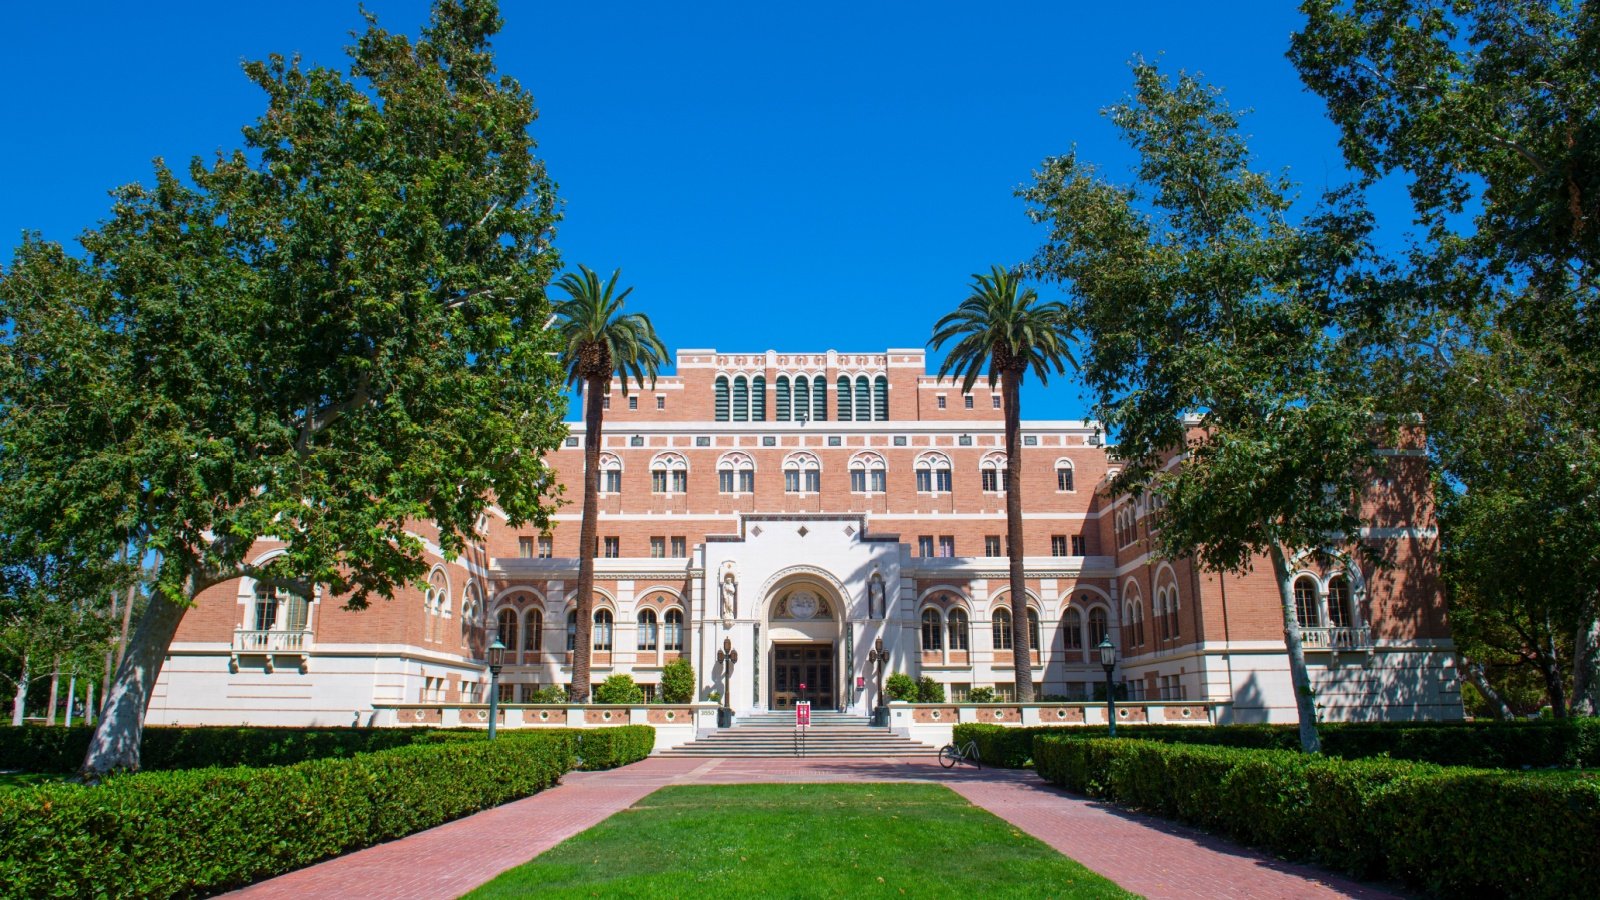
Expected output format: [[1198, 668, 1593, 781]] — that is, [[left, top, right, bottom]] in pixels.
[[763, 575, 846, 709]]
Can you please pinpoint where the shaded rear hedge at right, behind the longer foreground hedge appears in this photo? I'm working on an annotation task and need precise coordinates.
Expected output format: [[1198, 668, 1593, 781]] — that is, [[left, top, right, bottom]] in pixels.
[[955, 719, 1600, 769]]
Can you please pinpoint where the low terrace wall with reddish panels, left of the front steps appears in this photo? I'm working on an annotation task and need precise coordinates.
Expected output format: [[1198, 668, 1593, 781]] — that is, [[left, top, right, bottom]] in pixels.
[[363, 703, 717, 751]]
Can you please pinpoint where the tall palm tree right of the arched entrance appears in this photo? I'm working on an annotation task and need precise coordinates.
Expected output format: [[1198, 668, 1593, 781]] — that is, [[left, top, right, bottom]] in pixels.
[[928, 266, 1077, 703]]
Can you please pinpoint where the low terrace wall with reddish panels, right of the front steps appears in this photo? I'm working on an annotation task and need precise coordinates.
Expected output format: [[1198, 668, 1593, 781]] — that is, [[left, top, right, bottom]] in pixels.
[[890, 700, 1232, 746]]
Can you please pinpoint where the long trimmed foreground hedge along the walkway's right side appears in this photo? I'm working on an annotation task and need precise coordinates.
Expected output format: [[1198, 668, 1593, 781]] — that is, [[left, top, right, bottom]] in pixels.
[[1034, 735, 1600, 897]]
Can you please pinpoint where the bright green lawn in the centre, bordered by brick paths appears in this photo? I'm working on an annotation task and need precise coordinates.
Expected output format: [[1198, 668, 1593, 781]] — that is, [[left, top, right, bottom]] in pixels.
[[469, 785, 1131, 900]]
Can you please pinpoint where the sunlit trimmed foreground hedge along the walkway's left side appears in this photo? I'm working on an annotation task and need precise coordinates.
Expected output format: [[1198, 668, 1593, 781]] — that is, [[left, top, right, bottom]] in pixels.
[[0, 732, 576, 897]]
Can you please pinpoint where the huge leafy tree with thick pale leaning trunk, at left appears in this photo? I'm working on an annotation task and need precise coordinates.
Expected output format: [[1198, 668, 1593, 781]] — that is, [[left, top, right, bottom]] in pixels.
[[0, 0, 563, 777]]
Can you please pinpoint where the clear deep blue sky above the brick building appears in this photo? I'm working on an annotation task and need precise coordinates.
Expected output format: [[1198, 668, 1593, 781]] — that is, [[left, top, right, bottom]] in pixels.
[[0, 0, 1405, 418]]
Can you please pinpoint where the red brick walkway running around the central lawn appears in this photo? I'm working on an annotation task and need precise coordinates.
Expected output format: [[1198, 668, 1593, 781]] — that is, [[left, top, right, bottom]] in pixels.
[[237, 757, 1395, 900]]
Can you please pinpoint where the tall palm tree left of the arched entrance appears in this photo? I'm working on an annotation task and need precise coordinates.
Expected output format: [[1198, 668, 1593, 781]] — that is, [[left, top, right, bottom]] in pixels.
[[552, 266, 667, 703]]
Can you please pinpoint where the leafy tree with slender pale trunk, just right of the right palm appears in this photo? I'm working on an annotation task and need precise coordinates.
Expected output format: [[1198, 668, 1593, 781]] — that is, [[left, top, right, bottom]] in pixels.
[[1019, 61, 1379, 753]]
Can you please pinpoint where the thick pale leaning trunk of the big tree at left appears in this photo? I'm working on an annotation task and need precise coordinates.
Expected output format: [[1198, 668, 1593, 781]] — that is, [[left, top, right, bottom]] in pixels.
[[82, 591, 194, 781]]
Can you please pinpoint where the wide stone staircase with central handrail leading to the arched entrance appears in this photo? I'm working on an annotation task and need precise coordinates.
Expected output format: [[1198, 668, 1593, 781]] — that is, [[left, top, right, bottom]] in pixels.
[[656, 711, 938, 757]]
